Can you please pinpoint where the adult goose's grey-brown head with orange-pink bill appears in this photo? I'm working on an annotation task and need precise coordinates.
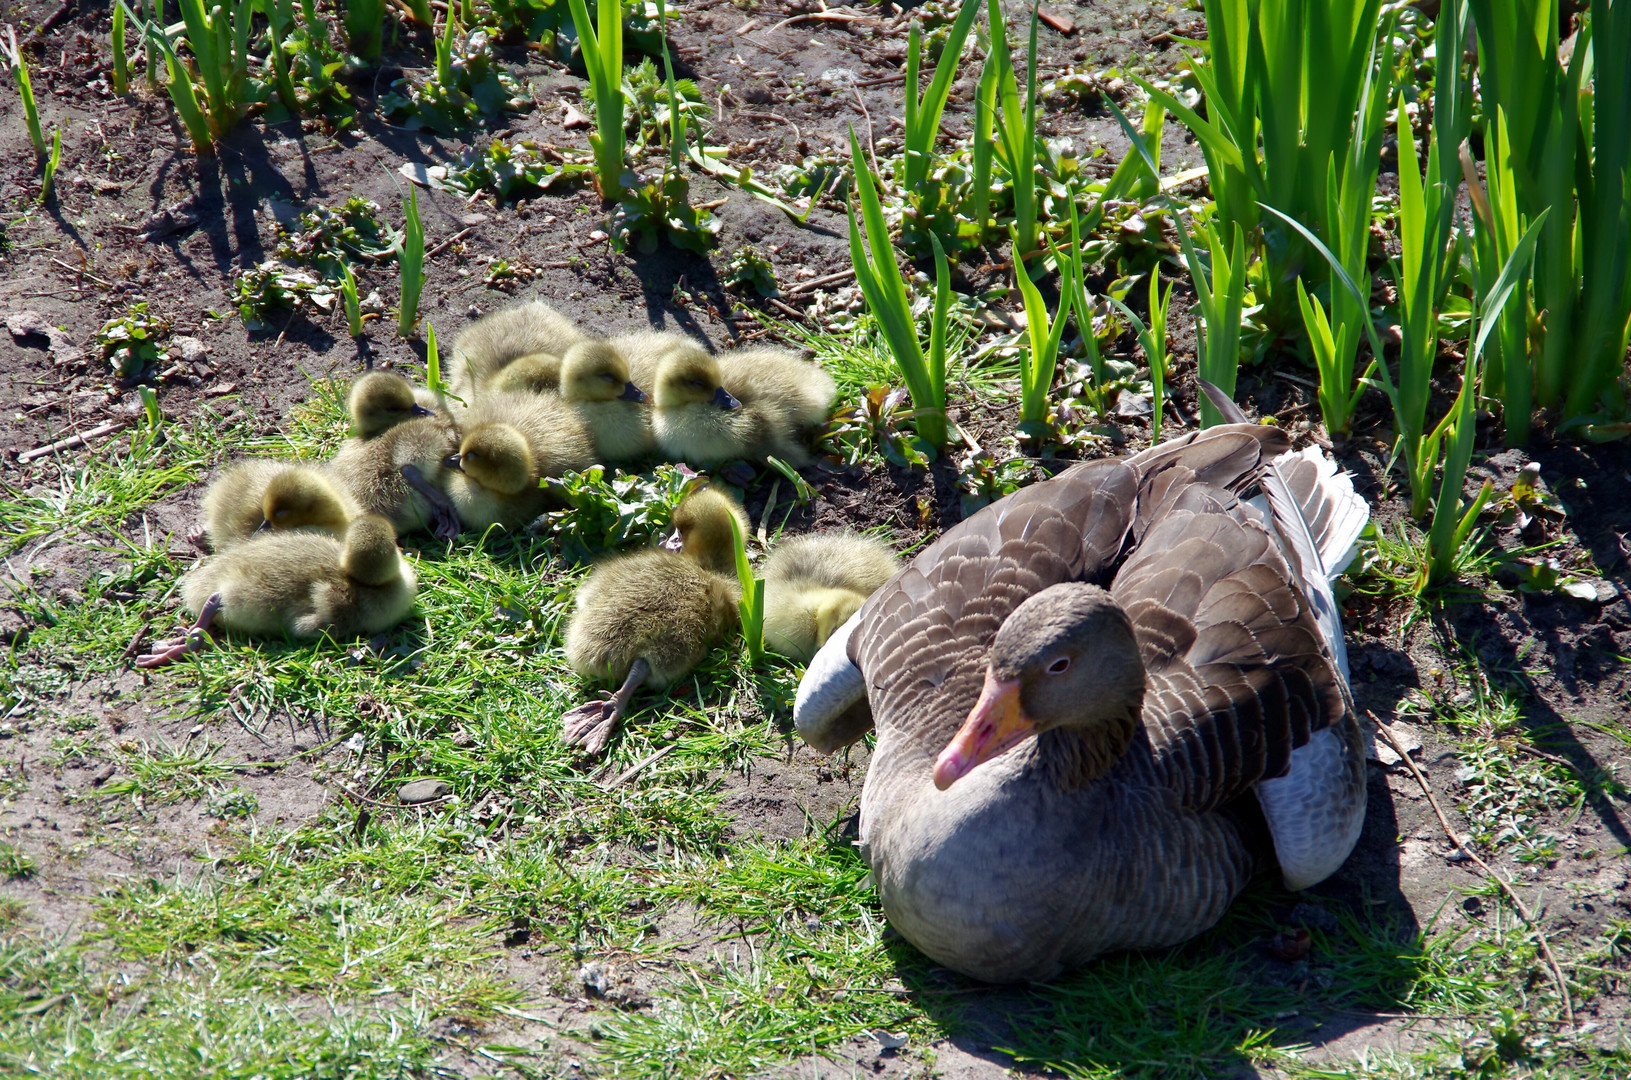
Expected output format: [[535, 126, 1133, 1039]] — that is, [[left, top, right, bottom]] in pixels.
[[935, 582, 1145, 791]]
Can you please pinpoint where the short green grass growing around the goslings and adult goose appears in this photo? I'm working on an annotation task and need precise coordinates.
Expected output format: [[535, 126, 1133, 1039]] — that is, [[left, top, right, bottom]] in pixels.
[[0, 398, 1624, 1080]]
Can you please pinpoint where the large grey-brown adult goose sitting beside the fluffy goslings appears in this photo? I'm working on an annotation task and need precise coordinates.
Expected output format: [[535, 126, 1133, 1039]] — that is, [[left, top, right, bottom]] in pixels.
[[794, 385, 1368, 982]]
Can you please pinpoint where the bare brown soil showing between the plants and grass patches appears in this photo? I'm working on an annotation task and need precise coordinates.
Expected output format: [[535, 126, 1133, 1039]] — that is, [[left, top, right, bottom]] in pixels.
[[0, 0, 1631, 1077]]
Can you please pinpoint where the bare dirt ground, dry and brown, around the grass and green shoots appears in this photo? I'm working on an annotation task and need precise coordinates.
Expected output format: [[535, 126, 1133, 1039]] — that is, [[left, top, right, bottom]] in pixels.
[[0, 0, 1631, 1078]]
